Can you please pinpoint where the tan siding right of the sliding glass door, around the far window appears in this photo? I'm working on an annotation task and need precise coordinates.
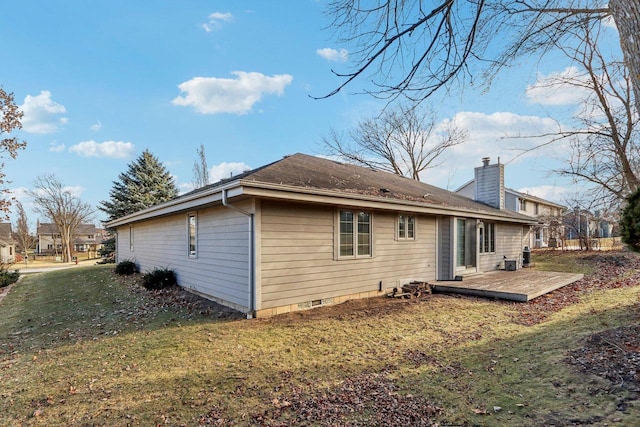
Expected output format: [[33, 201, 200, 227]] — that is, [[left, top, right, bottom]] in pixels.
[[478, 223, 529, 272]]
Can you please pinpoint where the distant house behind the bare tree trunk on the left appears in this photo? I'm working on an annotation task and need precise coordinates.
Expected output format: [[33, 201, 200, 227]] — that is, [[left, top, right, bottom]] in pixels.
[[36, 223, 104, 254]]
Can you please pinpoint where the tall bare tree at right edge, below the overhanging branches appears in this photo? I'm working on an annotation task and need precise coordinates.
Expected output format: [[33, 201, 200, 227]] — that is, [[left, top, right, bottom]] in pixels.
[[508, 25, 640, 209]]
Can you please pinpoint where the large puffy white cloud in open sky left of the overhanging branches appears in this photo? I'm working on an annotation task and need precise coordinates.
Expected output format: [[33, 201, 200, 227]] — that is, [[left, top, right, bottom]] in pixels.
[[171, 71, 293, 115]]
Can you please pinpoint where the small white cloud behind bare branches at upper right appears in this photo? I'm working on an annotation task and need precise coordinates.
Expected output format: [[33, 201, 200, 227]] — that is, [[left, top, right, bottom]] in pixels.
[[526, 67, 589, 105]]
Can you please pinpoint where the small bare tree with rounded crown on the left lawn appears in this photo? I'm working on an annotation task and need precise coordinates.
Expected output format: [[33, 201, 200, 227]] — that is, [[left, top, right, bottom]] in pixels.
[[29, 175, 93, 262]]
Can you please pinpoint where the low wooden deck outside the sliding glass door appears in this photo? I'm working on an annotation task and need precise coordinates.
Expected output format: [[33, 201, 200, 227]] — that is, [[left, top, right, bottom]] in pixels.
[[433, 268, 584, 302]]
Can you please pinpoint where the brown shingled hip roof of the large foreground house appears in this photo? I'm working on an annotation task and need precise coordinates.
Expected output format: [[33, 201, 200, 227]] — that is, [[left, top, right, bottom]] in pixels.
[[109, 153, 534, 226]]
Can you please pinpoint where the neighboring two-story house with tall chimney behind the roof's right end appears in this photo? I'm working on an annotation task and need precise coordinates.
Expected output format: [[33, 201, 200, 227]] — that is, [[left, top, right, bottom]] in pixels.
[[456, 157, 565, 248]]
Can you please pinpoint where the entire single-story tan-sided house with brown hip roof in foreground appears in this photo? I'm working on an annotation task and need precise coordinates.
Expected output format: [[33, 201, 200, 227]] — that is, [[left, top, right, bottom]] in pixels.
[[106, 154, 536, 316]]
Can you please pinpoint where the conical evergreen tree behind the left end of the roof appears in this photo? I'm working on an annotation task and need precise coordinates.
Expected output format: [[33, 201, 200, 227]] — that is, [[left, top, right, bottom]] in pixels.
[[98, 150, 178, 221]]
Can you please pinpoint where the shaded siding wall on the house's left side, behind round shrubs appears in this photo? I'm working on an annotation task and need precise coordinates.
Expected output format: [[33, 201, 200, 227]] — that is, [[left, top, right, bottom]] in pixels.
[[117, 207, 250, 310]]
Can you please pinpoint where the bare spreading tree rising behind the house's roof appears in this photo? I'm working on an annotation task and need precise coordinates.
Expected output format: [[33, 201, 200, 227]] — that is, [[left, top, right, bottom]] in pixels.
[[323, 105, 466, 181]]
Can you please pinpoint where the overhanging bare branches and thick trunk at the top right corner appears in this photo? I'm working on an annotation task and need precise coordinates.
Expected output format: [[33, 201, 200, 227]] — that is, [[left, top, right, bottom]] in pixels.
[[326, 0, 640, 115]]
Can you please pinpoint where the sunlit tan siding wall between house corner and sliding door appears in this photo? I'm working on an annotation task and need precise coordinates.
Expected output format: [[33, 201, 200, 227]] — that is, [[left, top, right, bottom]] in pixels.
[[260, 201, 436, 308]]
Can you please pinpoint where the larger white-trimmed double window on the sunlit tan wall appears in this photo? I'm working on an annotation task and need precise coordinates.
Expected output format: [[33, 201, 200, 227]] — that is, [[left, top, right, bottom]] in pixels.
[[338, 210, 372, 258]]
